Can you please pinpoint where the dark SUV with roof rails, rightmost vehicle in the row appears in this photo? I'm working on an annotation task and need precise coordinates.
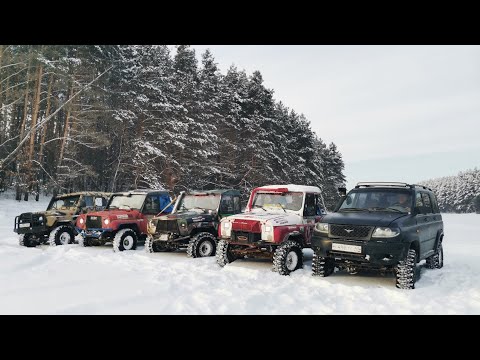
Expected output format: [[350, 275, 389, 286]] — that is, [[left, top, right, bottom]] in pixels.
[[312, 182, 443, 289]]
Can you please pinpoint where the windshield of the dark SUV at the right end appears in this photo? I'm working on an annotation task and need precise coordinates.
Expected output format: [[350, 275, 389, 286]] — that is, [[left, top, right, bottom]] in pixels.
[[338, 189, 412, 213]]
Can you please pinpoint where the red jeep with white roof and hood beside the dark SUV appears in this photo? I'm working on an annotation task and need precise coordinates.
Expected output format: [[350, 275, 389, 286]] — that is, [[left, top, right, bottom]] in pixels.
[[216, 184, 324, 275]]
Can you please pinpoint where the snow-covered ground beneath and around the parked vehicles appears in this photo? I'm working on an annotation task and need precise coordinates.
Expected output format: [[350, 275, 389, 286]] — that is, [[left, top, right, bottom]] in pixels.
[[0, 194, 480, 314]]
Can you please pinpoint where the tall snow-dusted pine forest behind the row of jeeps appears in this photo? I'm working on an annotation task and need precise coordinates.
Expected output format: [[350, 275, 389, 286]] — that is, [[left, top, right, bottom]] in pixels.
[[0, 45, 345, 207]]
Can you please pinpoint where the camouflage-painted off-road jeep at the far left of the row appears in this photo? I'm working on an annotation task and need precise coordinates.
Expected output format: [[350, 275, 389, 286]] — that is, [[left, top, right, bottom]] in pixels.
[[13, 192, 111, 247]]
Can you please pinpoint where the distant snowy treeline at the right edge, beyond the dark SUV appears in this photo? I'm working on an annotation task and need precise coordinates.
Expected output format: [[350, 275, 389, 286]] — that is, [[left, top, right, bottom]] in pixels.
[[420, 168, 480, 213]]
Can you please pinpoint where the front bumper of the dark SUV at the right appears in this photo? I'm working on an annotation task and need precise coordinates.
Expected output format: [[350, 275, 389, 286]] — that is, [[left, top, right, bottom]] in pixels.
[[312, 236, 409, 267]]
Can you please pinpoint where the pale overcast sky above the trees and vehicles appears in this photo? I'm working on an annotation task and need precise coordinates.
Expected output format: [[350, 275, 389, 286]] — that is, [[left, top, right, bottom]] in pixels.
[[188, 45, 480, 189]]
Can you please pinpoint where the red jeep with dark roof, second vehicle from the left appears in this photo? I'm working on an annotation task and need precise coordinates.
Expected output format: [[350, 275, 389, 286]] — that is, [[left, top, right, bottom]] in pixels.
[[75, 189, 173, 252]]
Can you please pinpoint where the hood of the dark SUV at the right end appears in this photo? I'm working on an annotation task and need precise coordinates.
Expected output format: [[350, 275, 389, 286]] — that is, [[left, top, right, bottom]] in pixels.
[[322, 211, 408, 226]]
